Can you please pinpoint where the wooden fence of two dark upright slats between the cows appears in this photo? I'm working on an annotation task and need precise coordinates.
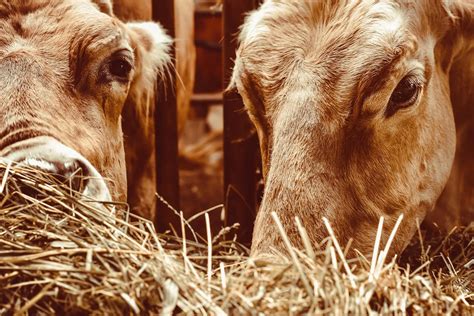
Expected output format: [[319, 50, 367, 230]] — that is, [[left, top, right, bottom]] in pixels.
[[153, 0, 260, 243]]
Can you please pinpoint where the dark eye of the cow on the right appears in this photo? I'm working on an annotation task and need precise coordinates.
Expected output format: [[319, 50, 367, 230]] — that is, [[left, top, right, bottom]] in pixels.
[[386, 76, 421, 116]]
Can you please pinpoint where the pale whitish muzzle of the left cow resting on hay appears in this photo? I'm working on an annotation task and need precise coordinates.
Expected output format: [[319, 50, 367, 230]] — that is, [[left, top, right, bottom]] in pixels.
[[0, 136, 111, 201]]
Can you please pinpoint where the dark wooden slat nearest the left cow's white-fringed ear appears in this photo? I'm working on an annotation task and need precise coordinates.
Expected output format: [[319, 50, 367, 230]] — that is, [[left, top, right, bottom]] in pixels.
[[153, 0, 179, 231]]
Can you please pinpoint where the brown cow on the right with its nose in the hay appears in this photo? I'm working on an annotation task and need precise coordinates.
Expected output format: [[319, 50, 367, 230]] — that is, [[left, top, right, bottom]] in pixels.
[[233, 0, 474, 254]]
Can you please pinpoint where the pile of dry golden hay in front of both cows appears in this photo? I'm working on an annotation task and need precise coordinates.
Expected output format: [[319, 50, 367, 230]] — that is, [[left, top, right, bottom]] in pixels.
[[0, 164, 474, 315]]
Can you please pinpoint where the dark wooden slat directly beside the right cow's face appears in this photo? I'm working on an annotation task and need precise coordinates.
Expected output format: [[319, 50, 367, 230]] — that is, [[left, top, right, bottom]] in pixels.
[[223, 0, 259, 243]]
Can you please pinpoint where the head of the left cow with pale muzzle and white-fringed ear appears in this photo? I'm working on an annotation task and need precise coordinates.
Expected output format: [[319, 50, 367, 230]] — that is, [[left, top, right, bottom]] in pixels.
[[0, 0, 170, 200]]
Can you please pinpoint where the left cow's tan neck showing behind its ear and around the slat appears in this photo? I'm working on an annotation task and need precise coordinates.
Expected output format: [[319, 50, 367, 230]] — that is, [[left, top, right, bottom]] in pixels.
[[114, 0, 196, 219]]
